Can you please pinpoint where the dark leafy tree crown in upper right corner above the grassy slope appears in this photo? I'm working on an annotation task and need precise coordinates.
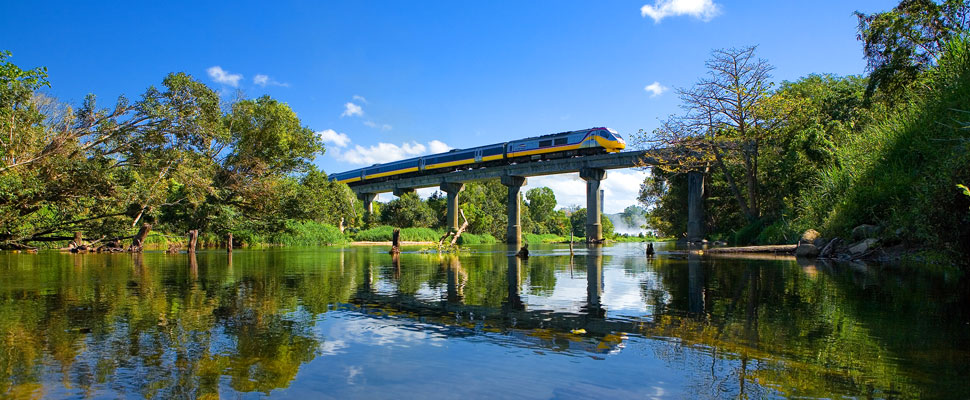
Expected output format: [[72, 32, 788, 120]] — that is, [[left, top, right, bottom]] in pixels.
[[855, 0, 970, 102]]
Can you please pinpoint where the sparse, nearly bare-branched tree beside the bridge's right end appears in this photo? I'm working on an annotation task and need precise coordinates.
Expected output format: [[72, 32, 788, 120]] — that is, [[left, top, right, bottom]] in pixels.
[[646, 46, 782, 220]]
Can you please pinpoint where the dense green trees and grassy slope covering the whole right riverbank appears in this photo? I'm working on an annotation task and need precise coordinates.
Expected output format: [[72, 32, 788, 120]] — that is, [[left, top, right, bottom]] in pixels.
[[637, 0, 970, 257]]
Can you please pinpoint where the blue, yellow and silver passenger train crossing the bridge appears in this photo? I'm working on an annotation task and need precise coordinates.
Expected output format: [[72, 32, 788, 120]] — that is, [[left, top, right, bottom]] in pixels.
[[330, 128, 626, 183]]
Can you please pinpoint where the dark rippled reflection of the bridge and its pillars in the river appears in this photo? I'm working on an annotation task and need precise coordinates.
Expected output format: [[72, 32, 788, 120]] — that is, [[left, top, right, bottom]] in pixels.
[[340, 247, 703, 353]]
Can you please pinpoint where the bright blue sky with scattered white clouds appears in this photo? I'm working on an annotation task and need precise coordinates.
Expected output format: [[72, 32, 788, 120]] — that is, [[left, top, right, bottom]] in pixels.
[[0, 0, 896, 212]]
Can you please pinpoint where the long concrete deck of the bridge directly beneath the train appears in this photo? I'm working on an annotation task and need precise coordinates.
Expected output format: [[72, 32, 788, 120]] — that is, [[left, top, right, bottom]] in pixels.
[[350, 151, 656, 193]]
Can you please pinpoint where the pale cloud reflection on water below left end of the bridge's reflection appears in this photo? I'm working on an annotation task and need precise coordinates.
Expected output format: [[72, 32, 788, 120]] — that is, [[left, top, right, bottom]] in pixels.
[[326, 316, 445, 347]]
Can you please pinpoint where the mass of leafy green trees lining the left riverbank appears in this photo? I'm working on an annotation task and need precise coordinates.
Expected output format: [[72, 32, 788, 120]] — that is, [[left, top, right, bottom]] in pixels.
[[0, 52, 348, 246]]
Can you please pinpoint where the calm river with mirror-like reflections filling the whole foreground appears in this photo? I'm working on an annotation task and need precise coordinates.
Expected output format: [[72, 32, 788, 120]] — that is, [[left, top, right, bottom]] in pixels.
[[0, 243, 970, 399]]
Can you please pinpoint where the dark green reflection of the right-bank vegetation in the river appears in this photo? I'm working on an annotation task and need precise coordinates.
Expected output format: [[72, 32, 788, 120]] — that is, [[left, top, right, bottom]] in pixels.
[[643, 258, 968, 397]]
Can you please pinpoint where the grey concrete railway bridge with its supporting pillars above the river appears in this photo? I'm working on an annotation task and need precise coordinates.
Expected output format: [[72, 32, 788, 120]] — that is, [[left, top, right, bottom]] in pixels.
[[350, 151, 704, 244]]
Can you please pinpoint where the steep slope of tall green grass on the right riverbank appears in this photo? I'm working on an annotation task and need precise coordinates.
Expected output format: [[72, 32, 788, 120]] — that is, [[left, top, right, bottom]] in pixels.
[[801, 38, 970, 253]]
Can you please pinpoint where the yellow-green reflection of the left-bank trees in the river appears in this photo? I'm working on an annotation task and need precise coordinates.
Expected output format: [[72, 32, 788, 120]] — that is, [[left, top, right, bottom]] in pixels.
[[0, 252, 357, 398]]
